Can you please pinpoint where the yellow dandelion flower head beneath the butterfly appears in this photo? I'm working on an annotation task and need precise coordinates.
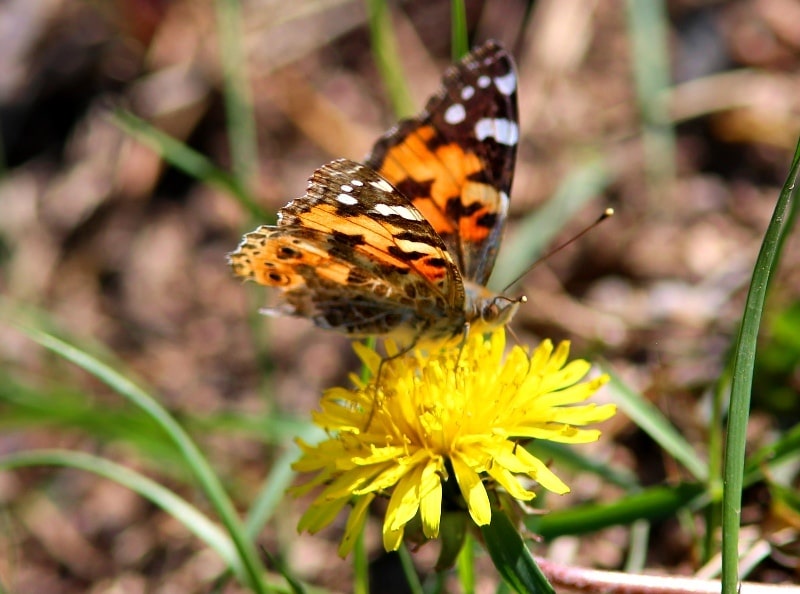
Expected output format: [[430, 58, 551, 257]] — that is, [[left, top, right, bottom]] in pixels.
[[294, 328, 616, 556]]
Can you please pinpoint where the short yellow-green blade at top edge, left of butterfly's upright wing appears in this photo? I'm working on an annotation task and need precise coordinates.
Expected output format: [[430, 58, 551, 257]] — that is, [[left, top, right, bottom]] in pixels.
[[366, 0, 416, 118]]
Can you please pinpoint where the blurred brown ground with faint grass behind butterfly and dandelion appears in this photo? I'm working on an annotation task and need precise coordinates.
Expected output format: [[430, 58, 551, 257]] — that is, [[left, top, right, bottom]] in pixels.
[[0, 0, 800, 594]]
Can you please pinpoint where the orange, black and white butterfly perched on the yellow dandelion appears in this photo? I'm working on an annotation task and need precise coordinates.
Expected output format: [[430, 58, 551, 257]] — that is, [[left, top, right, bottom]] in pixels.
[[229, 41, 524, 346]]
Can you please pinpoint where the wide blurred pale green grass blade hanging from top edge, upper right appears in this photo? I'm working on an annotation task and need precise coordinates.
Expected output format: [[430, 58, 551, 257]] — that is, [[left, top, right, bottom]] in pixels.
[[627, 0, 677, 199]]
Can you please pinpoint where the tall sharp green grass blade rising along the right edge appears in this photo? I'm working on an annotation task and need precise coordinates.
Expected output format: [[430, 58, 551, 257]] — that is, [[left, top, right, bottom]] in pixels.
[[722, 135, 800, 594]]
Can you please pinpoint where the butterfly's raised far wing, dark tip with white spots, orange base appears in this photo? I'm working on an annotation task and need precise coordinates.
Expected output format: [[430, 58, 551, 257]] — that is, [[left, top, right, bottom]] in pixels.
[[366, 41, 519, 285]]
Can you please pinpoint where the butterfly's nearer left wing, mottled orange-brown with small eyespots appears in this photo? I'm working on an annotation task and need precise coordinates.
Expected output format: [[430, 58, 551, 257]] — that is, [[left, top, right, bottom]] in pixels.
[[229, 159, 465, 337]]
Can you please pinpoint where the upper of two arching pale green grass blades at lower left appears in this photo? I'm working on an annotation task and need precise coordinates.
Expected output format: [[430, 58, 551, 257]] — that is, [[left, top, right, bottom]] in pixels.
[[17, 326, 270, 594]]
